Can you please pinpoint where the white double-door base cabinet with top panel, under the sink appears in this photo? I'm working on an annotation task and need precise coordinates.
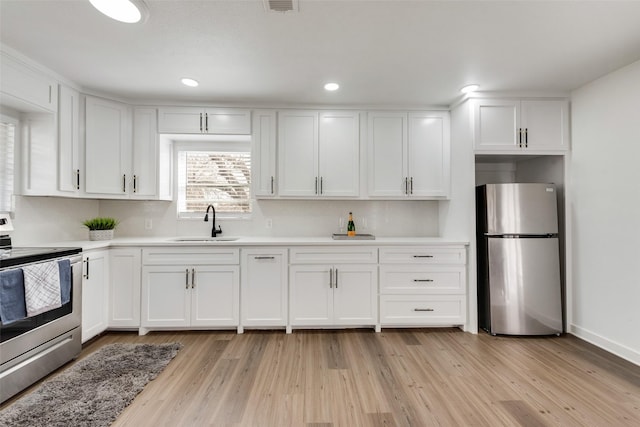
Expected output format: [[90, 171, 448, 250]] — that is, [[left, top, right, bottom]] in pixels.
[[140, 247, 240, 334]]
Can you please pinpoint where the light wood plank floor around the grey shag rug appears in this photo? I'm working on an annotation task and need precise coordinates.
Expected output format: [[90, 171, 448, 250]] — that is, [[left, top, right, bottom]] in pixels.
[[7, 329, 640, 427]]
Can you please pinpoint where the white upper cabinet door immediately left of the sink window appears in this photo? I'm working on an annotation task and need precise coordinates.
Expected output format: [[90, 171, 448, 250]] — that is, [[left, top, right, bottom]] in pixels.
[[129, 108, 159, 199]]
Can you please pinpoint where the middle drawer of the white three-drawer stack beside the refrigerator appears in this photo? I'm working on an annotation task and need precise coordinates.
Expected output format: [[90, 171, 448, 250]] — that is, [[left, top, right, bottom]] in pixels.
[[380, 264, 466, 294]]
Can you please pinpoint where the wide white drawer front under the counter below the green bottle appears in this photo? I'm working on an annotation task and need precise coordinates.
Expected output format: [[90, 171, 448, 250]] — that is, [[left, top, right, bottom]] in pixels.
[[289, 246, 378, 264]]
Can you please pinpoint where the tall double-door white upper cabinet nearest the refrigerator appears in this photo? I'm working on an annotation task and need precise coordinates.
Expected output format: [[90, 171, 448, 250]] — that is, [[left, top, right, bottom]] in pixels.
[[367, 111, 450, 199]]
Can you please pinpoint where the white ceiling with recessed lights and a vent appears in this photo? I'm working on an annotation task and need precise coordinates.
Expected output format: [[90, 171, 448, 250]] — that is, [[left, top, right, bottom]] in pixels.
[[0, 0, 640, 106]]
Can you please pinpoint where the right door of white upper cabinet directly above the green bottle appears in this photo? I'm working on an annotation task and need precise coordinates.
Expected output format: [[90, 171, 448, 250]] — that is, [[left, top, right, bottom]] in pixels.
[[318, 111, 360, 197]]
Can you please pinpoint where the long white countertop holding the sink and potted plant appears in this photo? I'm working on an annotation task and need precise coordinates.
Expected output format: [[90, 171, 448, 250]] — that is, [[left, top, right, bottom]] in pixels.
[[38, 236, 469, 251]]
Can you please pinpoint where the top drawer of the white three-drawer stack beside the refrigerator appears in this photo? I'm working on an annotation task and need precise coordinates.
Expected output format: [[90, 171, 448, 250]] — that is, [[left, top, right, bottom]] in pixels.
[[380, 246, 467, 264]]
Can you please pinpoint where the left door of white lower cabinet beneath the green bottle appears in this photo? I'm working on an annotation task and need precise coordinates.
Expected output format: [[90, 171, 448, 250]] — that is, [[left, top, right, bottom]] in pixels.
[[289, 265, 333, 326]]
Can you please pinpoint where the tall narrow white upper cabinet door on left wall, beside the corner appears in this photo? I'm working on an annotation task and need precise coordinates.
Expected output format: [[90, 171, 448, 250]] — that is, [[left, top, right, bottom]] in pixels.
[[58, 85, 80, 193]]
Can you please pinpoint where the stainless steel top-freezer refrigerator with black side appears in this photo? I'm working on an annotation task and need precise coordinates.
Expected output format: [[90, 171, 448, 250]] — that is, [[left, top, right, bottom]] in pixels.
[[476, 184, 562, 335]]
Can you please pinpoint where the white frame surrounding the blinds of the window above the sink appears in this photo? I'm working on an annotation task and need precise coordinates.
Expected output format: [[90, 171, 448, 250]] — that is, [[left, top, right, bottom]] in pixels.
[[173, 137, 255, 221]]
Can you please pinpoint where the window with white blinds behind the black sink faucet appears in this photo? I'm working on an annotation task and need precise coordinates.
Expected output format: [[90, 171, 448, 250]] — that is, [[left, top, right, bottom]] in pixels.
[[178, 143, 251, 218]]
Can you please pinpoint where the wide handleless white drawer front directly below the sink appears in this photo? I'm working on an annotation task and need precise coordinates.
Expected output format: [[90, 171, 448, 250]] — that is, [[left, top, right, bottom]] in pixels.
[[142, 247, 240, 265]]
